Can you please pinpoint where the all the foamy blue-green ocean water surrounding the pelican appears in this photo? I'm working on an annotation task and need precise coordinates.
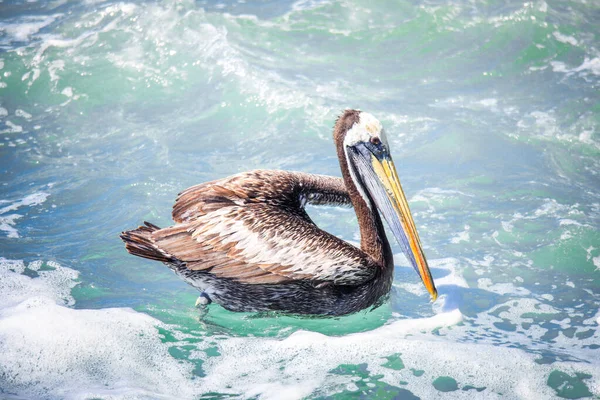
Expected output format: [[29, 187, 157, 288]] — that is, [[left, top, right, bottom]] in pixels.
[[0, 0, 600, 400]]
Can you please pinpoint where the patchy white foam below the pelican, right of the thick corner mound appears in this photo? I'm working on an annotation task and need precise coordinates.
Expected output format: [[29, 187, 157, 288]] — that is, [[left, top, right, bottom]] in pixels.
[[197, 304, 598, 399]]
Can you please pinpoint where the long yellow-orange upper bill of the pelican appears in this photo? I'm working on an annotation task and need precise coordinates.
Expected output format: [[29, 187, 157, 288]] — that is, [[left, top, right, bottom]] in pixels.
[[371, 155, 438, 301]]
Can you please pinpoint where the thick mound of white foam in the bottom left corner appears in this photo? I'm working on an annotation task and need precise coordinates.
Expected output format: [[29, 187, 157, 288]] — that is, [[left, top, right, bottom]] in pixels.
[[0, 259, 199, 399]]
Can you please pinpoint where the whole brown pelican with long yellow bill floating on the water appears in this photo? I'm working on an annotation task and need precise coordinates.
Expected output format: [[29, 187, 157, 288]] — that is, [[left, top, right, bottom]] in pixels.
[[121, 110, 437, 315]]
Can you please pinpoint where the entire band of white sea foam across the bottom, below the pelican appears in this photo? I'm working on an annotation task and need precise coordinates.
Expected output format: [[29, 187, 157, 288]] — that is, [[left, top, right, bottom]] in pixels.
[[0, 255, 600, 399]]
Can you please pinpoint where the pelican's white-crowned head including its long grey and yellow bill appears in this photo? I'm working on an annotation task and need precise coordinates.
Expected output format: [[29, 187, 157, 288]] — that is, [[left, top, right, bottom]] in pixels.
[[341, 110, 437, 301]]
